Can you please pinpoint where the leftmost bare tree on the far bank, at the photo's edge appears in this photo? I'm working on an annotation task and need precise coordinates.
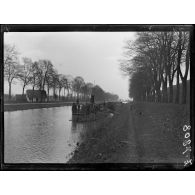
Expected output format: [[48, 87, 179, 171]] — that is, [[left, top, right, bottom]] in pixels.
[[4, 44, 20, 100]]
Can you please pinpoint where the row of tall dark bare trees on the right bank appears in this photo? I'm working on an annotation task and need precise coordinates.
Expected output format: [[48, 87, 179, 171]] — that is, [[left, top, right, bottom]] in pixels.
[[120, 31, 190, 104]]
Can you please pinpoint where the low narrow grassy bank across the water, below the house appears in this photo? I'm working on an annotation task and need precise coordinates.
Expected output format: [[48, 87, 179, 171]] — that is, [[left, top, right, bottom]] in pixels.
[[4, 102, 72, 112]]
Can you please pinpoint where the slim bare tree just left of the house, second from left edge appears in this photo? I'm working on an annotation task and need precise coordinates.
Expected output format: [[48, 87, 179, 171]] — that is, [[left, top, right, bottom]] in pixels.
[[18, 57, 33, 95]]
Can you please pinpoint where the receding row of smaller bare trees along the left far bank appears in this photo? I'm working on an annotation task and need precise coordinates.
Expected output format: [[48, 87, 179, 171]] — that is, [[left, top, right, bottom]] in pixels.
[[4, 44, 118, 101]]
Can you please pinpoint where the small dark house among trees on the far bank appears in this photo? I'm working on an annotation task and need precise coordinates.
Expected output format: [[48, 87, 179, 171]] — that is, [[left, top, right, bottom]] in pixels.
[[26, 90, 47, 102]]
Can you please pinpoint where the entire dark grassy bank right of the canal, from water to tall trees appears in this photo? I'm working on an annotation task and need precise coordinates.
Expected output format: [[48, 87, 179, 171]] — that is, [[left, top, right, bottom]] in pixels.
[[69, 103, 190, 167]]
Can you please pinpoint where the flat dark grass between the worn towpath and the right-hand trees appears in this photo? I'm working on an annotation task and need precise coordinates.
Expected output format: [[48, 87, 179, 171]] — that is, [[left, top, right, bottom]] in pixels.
[[132, 103, 190, 163]]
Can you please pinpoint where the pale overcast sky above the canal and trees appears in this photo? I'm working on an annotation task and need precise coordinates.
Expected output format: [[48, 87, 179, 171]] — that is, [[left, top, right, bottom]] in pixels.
[[4, 32, 135, 99]]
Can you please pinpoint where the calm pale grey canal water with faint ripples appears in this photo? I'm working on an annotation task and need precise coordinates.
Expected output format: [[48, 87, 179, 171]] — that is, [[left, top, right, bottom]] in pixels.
[[4, 106, 91, 163]]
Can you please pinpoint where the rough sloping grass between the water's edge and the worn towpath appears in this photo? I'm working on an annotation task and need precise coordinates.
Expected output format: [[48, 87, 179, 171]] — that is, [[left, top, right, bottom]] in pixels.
[[68, 103, 133, 163]]
